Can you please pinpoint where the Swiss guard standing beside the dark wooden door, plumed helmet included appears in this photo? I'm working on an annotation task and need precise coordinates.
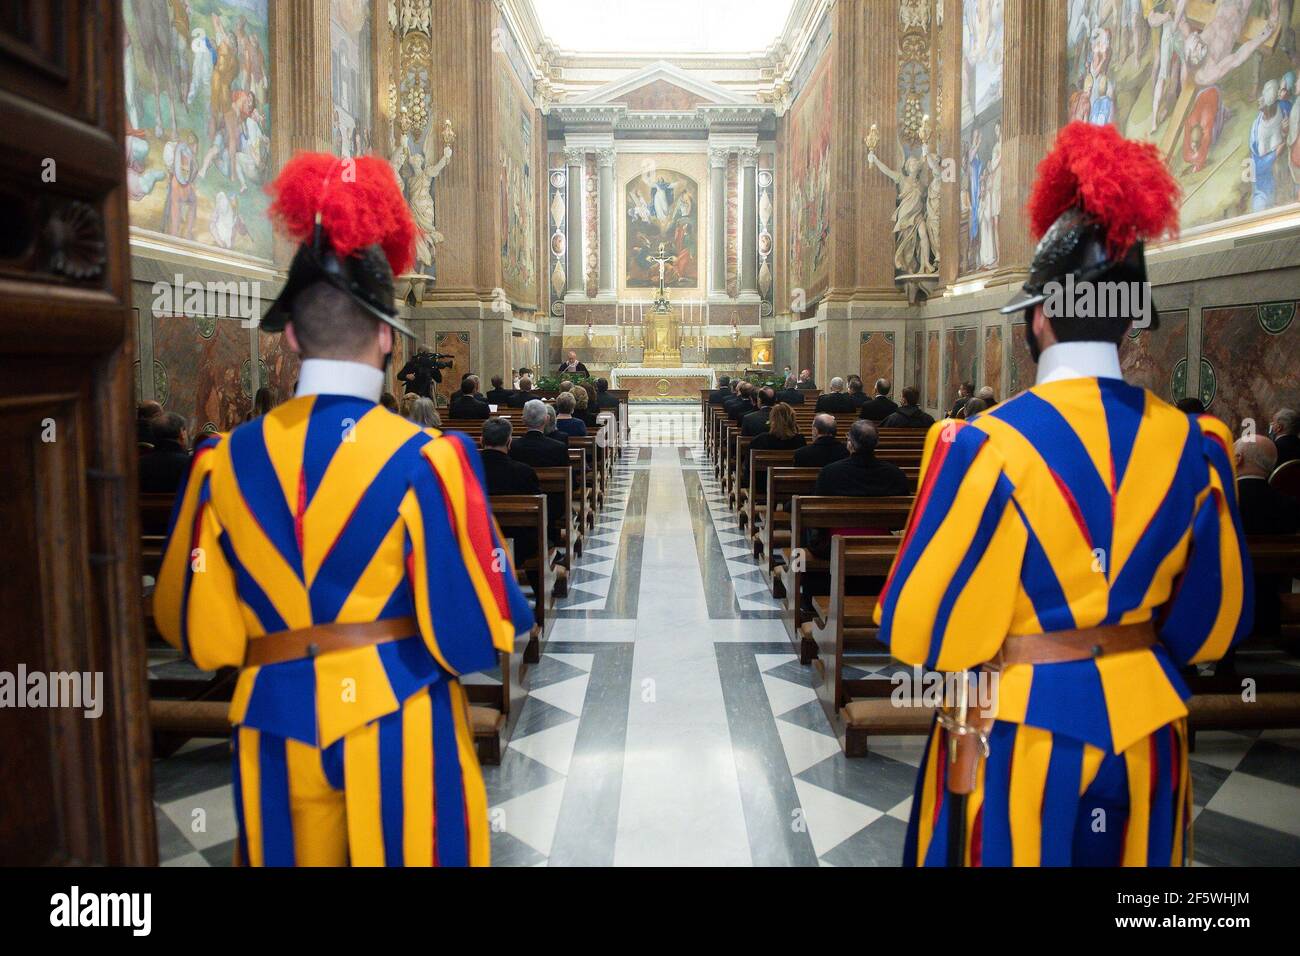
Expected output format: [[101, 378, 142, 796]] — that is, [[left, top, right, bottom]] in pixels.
[[153, 153, 533, 866]]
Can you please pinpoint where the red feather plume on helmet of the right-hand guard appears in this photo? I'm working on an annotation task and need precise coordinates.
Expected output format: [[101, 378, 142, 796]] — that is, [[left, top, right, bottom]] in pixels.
[[1028, 121, 1180, 259]]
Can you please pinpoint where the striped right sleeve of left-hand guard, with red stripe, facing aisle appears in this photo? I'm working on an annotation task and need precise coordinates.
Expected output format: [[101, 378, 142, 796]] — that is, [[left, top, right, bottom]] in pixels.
[[400, 433, 533, 674]]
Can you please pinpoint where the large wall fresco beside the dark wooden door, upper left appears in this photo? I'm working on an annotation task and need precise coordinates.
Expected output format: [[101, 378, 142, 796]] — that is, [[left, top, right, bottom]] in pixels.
[[124, 0, 272, 259]]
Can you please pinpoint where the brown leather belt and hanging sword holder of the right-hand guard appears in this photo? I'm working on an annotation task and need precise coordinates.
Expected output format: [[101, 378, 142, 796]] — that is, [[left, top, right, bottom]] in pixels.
[[939, 620, 1156, 795]]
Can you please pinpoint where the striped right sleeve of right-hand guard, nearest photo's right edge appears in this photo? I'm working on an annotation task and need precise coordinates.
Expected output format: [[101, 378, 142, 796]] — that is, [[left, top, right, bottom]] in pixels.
[[1160, 415, 1255, 665]]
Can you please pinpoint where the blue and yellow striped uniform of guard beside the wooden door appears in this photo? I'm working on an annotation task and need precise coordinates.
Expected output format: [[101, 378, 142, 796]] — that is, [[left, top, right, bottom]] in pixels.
[[153, 395, 533, 866]]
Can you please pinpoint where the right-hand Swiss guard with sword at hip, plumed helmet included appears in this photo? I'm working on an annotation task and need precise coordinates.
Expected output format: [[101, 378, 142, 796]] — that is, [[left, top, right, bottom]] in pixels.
[[875, 122, 1253, 866]]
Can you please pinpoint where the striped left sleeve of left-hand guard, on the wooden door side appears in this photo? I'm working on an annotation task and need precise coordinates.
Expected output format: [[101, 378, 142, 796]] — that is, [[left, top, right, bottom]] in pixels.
[[153, 436, 247, 670]]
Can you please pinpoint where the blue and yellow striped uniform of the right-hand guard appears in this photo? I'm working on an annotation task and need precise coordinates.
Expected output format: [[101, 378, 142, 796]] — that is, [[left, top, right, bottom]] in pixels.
[[876, 378, 1253, 865]]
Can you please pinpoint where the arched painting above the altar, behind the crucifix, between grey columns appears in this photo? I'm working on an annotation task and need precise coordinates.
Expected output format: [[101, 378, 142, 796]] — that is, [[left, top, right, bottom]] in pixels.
[[623, 165, 699, 289]]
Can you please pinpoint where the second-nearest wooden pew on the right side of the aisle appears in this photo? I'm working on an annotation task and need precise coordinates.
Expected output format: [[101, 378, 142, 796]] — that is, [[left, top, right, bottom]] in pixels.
[[781, 494, 914, 663]]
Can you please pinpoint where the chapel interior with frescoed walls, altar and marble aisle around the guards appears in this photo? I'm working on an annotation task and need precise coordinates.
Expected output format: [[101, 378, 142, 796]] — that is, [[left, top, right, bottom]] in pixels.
[[0, 0, 1300, 866]]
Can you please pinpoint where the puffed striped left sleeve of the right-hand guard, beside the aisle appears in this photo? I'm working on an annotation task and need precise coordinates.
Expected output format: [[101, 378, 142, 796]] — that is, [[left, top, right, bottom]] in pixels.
[[875, 421, 1027, 670]]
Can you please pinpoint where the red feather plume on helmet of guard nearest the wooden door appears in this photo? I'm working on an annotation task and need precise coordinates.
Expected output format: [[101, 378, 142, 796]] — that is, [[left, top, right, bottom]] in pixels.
[[267, 152, 417, 276]]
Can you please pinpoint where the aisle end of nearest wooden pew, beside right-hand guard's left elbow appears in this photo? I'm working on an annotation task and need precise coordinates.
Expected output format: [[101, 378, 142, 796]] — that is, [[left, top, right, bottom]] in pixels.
[[811, 535, 935, 757]]
